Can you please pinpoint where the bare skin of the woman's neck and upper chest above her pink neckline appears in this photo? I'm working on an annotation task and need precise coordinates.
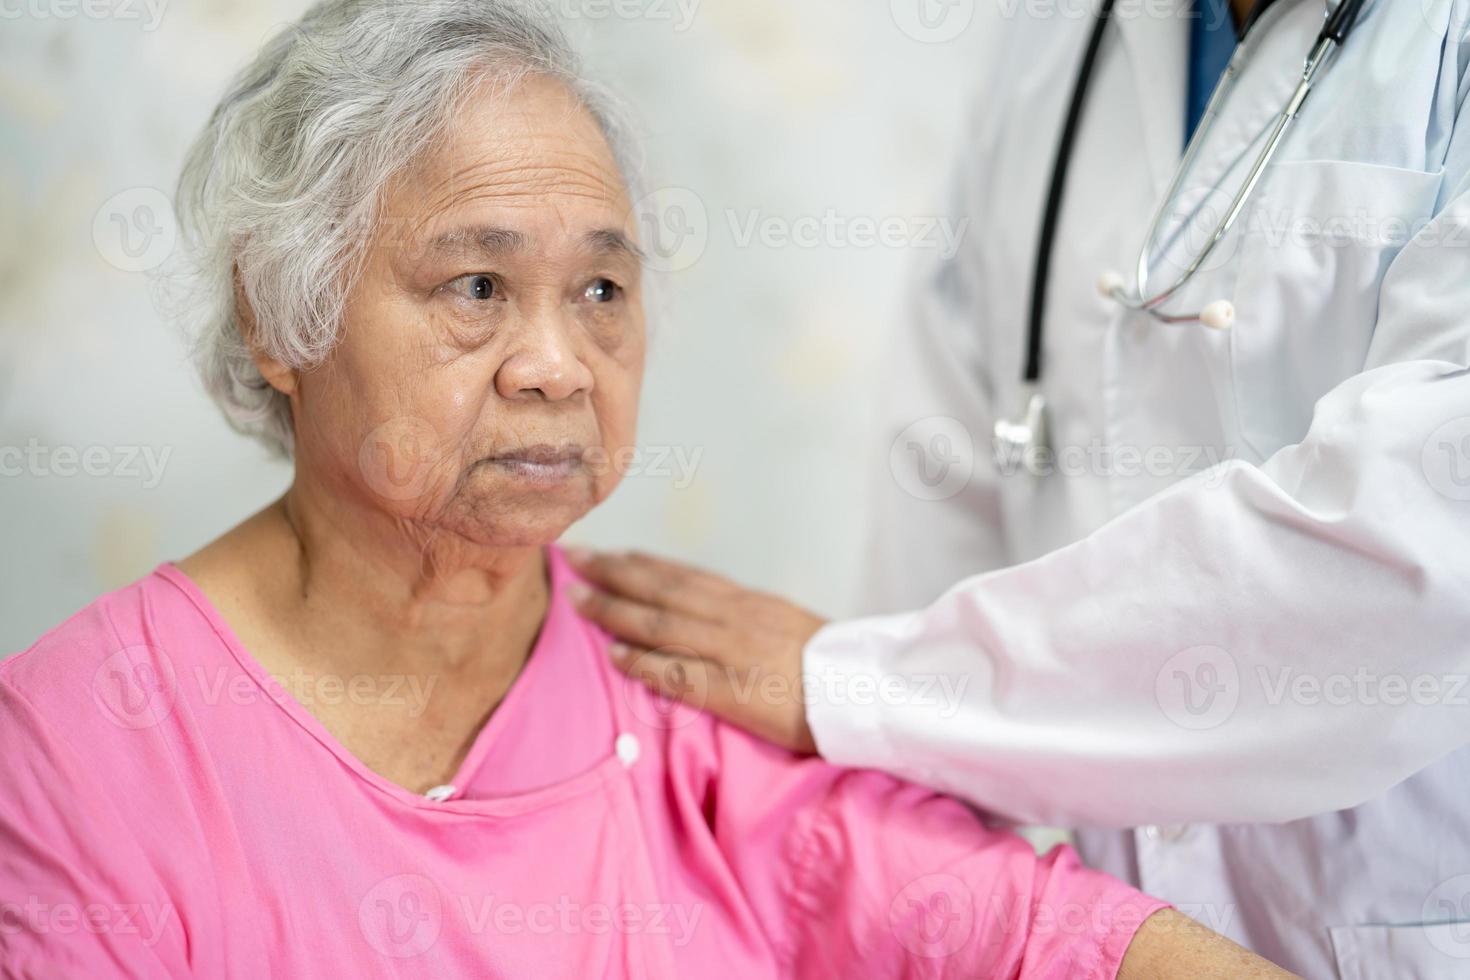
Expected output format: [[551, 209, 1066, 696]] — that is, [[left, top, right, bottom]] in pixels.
[[178, 486, 550, 792]]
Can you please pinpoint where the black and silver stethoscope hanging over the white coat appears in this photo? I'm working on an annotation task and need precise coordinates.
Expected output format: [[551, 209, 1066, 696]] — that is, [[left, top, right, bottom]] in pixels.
[[994, 0, 1366, 475]]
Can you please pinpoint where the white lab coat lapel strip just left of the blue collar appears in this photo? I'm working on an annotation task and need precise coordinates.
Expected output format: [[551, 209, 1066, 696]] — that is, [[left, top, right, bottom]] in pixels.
[[1103, 0, 1191, 200]]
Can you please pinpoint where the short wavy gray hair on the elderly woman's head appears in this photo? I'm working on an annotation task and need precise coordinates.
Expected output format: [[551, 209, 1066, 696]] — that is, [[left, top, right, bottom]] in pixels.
[[176, 0, 635, 455]]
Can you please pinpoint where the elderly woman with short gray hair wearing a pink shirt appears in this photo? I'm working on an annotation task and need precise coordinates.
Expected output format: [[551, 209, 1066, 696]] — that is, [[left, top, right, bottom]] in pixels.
[[0, 0, 1293, 979]]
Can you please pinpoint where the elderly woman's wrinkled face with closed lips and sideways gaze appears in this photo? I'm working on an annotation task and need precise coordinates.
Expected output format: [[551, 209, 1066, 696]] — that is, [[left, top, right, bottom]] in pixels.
[[293, 78, 644, 547]]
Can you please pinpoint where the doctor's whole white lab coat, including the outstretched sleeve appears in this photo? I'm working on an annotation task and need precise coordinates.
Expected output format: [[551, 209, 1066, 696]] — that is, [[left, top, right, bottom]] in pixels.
[[804, 0, 1470, 979]]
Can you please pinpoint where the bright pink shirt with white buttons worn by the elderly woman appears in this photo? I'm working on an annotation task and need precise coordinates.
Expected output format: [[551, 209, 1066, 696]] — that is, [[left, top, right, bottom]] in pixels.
[[0, 551, 1161, 980]]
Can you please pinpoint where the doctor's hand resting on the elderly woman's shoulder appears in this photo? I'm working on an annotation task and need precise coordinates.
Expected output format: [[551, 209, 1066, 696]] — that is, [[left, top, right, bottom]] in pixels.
[[566, 548, 826, 754]]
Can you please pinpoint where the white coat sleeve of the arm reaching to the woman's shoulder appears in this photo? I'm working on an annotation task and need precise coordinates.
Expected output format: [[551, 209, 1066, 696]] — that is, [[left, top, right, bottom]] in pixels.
[[804, 94, 1470, 826]]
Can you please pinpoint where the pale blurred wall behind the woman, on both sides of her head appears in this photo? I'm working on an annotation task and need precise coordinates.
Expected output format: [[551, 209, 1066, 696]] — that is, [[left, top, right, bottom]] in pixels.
[[0, 0, 991, 652]]
